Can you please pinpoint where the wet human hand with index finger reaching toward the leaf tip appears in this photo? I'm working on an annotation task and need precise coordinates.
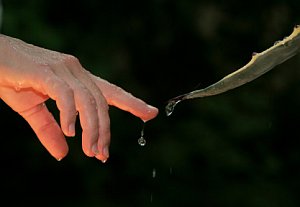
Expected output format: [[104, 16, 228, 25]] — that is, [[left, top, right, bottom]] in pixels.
[[0, 35, 158, 161]]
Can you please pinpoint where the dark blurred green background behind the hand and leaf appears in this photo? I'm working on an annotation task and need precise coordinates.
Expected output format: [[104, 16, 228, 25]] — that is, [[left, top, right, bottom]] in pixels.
[[0, 0, 300, 207]]
